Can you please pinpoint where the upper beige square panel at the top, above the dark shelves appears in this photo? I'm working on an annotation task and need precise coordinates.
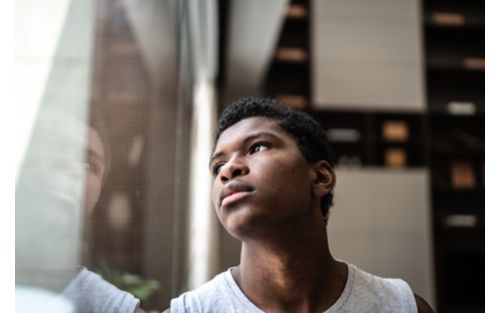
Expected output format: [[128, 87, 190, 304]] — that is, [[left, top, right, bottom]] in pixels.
[[311, 0, 425, 111]]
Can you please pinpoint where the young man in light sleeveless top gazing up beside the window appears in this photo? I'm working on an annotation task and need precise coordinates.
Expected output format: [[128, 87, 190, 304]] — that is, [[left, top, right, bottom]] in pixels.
[[167, 98, 432, 313]]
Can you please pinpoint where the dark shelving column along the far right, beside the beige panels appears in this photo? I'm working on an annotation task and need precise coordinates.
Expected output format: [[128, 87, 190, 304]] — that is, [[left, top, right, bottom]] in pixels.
[[423, 0, 485, 312]]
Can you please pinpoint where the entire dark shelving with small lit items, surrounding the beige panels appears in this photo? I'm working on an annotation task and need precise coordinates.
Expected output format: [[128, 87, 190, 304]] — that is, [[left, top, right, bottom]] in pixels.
[[265, 0, 485, 313]]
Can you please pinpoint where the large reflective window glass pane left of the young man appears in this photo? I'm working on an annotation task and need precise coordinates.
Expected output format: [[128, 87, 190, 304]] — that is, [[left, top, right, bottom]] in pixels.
[[16, 0, 191, 312]]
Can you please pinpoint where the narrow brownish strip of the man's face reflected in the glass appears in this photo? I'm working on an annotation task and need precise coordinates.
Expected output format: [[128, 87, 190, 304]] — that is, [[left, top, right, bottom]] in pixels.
[[85, 127, 106, 215]]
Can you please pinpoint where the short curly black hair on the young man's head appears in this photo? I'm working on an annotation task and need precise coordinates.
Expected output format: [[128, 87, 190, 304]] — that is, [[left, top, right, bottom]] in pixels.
[[215, 98, 333, 223]]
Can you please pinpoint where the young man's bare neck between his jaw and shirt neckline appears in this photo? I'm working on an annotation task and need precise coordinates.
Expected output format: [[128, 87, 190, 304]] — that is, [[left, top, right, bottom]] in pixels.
[[233, 217, 347, 312]]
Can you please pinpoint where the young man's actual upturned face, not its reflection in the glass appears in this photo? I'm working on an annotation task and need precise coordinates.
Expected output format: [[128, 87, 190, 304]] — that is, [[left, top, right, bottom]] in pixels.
[[210, 117, 314, 239]]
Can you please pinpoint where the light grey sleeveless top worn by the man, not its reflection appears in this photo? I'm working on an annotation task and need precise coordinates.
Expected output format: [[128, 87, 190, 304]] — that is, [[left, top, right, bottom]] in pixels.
[[170, 264, 417, 313]]
